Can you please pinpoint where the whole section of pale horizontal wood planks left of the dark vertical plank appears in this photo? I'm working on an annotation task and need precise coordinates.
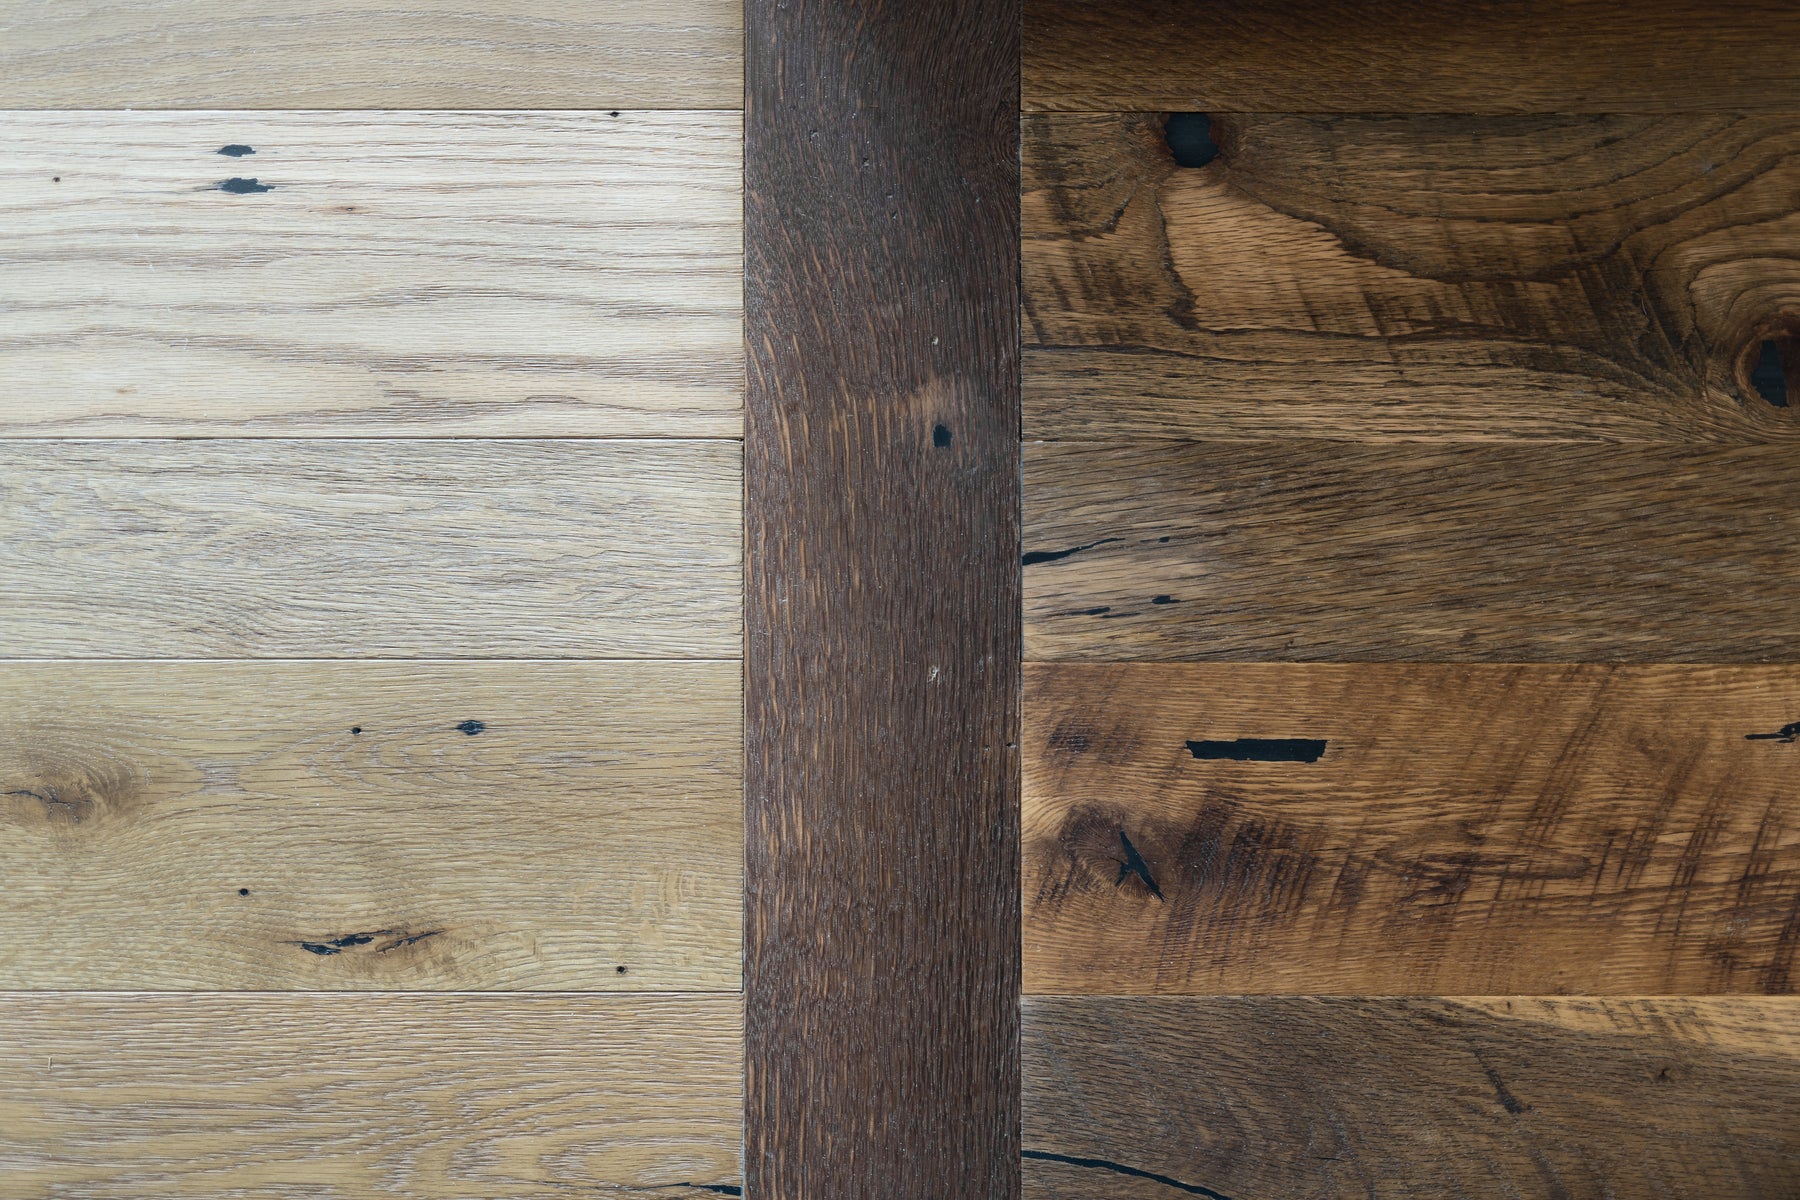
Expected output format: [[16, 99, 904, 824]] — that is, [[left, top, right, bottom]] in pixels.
[[0, 0, 743, 1200]]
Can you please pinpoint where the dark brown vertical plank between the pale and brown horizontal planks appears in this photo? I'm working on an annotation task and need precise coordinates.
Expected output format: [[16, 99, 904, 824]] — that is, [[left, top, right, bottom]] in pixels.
[[745, 0, 1019, 1200]]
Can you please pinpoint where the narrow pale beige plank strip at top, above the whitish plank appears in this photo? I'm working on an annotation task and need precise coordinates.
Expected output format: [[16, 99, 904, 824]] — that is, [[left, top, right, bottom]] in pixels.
[[0, 0, 743, 108]]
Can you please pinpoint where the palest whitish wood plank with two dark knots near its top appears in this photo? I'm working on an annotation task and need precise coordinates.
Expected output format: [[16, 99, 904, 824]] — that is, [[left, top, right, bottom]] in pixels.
[[0, 111, 743, 437]]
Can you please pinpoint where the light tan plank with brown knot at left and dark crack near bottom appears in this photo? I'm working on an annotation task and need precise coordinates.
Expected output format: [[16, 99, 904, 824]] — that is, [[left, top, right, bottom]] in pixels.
[[0, 662, 743, 991]]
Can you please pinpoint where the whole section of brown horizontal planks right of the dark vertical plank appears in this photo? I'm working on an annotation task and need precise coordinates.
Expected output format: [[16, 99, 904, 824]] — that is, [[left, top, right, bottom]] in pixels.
[[1021, 0, 1800, 1200]]
